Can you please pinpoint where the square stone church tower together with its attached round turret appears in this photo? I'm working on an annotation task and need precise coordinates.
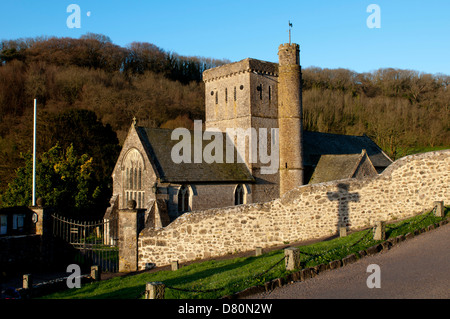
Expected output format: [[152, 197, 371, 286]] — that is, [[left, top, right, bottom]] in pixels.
[[203, 44, 304, 202]]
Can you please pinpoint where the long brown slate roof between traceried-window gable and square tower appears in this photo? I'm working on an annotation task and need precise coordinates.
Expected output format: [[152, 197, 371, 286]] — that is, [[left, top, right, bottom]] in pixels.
[[136, 126, 254, 183]]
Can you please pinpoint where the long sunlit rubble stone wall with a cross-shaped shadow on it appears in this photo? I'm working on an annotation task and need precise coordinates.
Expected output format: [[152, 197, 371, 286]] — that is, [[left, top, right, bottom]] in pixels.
[[138, 150, 450, 269]]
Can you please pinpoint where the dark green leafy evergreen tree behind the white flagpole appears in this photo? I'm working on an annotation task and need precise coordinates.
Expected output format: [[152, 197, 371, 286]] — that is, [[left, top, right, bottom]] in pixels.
[[1, 145, 104, 216]]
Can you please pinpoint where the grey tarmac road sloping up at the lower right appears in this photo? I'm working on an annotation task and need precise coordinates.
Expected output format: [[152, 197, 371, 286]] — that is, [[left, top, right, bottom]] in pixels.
[[246, 224, 450, 299]]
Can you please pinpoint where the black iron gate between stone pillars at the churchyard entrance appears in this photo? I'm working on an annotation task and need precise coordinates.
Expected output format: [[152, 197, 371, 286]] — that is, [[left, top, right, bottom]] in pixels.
[[52, 214, 119, 272]]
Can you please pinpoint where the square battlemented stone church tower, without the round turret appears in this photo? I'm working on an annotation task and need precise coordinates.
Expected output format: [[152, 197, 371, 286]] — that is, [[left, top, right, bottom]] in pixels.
[[203, 58, 279, 202]]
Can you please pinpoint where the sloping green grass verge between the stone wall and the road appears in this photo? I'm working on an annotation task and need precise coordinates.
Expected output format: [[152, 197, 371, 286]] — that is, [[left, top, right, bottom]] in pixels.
[[43, 207, 450, 299]]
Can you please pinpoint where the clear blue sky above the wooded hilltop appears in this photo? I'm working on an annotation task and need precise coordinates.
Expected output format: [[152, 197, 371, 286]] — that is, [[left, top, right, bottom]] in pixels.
[[0, 0, 450, 75]]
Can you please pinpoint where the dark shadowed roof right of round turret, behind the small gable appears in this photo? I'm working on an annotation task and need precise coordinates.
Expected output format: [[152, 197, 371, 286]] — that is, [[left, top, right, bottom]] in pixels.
[[303, 131, 392, 168]]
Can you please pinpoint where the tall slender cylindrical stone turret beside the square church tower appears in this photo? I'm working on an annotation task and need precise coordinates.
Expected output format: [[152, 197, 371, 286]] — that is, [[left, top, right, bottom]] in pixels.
[[278, 43, 304, 196]]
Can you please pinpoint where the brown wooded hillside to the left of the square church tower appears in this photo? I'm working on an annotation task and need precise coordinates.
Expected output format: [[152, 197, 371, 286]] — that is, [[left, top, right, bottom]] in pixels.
[[0, 34, 229, 198]]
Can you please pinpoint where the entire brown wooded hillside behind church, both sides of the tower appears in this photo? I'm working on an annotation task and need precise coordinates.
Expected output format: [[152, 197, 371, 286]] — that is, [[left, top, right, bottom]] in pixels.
[[0, 34, 450, 205]]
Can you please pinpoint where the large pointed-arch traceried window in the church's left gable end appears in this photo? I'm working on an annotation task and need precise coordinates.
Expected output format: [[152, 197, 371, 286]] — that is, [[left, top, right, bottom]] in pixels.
[[123, 149, 145, 208]]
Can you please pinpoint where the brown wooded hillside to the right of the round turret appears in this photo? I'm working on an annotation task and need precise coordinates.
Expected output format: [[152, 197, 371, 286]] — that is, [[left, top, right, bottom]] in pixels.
[[303, 68, 450, 159]]
